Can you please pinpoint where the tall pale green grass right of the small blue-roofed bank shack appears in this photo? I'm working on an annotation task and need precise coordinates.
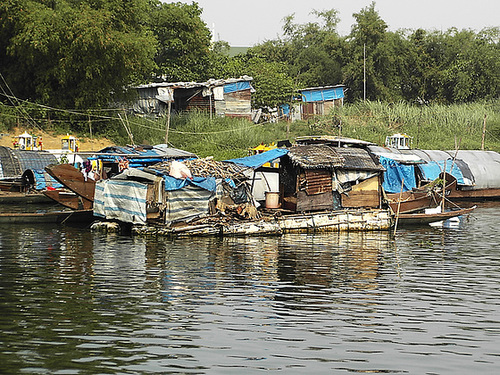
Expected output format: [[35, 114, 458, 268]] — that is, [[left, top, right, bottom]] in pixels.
[[335, 102, 500, 151]]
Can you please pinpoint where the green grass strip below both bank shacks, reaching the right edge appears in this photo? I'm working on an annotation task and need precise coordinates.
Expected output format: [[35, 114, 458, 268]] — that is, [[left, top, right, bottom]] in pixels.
[[115, 101, 500, 160]]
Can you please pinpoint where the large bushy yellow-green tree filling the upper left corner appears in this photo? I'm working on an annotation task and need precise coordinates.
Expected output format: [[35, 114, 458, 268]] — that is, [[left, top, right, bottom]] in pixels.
[[0, 0, 155, 109]]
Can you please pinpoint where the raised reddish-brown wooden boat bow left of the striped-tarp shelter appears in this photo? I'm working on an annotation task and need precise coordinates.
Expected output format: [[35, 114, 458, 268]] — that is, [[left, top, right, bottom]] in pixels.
[[45, 164, 95, 202]]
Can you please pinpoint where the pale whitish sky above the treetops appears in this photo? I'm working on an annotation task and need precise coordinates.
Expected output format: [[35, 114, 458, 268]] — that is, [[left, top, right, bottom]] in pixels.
[[172, 0, 500, 47]]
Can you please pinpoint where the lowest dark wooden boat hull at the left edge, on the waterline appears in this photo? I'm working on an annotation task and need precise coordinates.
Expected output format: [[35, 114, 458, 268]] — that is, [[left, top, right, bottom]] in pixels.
[[0, 210, 94, 224]]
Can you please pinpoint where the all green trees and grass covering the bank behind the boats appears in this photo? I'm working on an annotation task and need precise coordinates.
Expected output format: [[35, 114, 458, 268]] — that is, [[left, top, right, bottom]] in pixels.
[[0, 0, 500, 159]]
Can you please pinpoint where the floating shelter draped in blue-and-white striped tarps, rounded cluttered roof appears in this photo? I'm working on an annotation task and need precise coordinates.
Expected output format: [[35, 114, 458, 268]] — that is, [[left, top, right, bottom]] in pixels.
[[94, 159, 252, 228]]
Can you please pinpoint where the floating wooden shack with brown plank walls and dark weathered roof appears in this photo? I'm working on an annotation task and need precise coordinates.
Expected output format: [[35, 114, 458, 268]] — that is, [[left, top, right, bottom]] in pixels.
[[280, 144, 383, 212]]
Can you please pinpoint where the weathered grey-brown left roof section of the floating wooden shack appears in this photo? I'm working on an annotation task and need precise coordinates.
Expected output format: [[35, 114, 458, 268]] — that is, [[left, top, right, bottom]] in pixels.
[[288, 144, 345, 169]]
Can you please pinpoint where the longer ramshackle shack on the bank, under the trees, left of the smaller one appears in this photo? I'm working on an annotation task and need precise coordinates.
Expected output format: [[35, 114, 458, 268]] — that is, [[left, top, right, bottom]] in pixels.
[[132, 76, 254, 120]]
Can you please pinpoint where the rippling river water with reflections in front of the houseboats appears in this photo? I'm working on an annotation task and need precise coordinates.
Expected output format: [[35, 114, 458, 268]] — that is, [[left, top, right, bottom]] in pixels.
[[0, 203, 500, 374]]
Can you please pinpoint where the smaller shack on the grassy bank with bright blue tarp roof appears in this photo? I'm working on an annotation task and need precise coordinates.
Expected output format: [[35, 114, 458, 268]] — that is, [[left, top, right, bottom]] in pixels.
[[298, 85, 346, 120]]
